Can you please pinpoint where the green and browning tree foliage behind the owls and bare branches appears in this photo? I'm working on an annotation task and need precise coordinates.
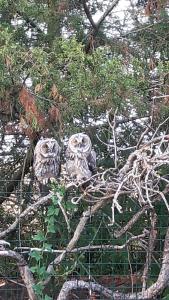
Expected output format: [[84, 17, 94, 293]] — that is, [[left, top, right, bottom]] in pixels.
[[0, 0, 169, 300]]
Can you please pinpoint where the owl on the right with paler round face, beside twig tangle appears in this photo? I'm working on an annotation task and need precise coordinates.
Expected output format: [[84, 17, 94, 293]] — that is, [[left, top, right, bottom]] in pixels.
[[66, 133, 96, 182]]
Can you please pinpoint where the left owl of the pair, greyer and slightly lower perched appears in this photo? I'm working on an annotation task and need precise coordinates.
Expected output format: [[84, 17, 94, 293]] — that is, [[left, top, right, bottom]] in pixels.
[[33, 138, 60, 192]]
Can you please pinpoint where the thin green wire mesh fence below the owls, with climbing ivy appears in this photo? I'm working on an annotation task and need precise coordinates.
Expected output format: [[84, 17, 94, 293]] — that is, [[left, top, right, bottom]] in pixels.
[[0, 180, 168, 300]]
